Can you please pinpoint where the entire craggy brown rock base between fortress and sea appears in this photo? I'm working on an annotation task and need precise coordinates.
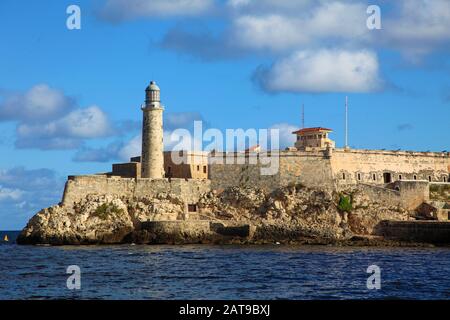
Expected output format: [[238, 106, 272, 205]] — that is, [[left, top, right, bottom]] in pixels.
[[18, 185, 409, 245]]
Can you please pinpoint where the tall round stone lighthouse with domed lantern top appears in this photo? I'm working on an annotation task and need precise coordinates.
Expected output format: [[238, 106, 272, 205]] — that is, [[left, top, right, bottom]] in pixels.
[[141, 81, 164, 179]]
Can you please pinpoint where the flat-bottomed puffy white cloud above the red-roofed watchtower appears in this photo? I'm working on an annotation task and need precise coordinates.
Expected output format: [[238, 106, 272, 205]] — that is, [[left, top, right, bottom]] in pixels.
[[255, 50, 381, 93]]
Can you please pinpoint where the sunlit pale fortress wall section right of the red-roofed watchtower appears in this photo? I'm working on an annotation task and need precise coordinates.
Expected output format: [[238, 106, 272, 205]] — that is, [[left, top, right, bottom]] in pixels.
[[331, 149, 450, 185]]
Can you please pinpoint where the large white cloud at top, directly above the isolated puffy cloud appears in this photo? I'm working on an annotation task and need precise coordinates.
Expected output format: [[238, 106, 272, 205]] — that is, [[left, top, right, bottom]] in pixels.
[[232, 1, 370, 51]]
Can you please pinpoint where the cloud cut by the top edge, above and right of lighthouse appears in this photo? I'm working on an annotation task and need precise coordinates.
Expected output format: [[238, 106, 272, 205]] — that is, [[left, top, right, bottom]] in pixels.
[[99, 0, 214, 22]]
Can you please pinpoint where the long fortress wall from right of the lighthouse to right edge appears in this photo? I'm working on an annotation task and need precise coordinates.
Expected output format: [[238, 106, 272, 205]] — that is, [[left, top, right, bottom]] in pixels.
[[209, 149, 450, 192]]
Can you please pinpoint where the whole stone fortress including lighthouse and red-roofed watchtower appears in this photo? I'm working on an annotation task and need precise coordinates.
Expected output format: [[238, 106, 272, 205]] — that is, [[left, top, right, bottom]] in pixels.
[[63, 81, 450, 220]]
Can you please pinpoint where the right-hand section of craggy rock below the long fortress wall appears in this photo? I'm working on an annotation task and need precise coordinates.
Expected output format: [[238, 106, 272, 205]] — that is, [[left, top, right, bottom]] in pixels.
[[200, 185, 410, 242]]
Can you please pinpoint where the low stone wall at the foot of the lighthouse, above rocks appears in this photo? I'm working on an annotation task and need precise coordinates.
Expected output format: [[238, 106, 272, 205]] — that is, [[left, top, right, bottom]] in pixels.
[[62, 175, 210, 204]]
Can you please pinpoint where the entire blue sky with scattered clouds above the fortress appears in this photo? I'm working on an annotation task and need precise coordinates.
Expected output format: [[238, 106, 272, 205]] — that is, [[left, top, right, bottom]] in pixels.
[[0, 0, 450, 229]]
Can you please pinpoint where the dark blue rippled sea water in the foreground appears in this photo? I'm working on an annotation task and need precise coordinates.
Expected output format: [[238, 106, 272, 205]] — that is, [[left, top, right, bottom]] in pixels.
[[0, 231, 450, 299]]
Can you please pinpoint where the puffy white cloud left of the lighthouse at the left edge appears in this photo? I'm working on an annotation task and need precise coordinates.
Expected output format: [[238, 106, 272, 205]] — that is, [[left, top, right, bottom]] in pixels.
[[0, 84, 114, 150]]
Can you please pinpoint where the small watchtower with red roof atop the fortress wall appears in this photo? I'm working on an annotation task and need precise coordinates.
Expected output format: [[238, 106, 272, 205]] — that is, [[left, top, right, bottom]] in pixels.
[[293, 127, 335, 151]]
